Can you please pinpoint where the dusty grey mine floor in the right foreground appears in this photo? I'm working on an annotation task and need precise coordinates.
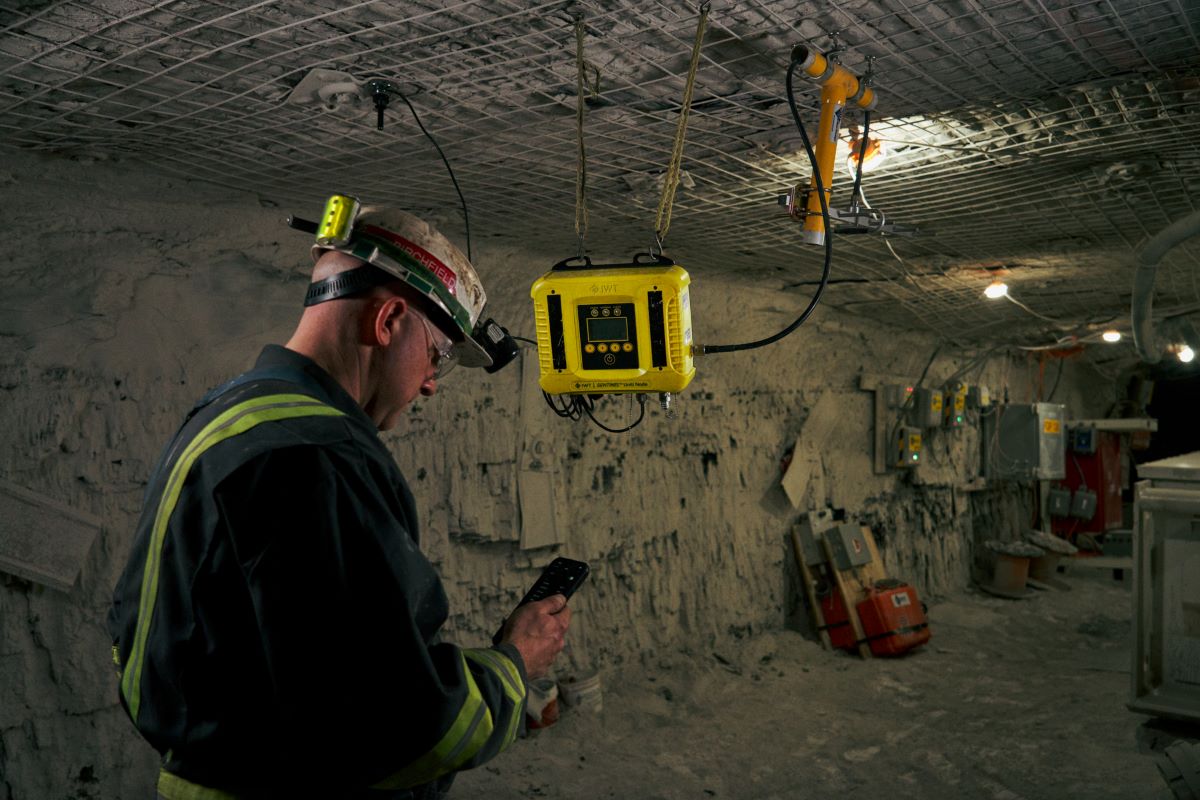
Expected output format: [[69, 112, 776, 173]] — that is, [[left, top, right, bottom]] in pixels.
[[450, 571, 1171, 800]]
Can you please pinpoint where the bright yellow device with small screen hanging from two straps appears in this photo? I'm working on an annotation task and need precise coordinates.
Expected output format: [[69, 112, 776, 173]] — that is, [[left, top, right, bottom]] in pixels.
[[530, 255, 696, 395]]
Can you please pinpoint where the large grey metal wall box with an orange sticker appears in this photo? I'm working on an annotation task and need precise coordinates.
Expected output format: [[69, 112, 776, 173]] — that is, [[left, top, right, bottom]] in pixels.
[[982, 403, 1066, 481]]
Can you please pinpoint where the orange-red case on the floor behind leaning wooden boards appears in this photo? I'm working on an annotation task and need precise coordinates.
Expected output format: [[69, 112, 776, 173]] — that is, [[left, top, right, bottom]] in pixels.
[[821, 582, 931, 656]]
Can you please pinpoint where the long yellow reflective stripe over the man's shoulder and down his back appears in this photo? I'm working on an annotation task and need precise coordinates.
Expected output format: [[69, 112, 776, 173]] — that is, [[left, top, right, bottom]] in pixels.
[[121, 395, 344, 722]]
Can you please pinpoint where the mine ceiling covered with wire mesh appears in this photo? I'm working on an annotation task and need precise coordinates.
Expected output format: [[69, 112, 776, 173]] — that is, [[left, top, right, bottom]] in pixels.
[[0, 0, 1200, 367]]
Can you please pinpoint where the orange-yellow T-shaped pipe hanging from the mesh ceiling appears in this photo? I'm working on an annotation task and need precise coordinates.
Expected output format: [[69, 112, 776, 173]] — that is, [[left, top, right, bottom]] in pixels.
[[792, 44, 876, 245]]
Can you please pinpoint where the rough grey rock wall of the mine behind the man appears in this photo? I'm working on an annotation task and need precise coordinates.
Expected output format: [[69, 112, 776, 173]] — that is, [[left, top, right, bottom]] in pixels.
[[0, 154, 1105, 798]]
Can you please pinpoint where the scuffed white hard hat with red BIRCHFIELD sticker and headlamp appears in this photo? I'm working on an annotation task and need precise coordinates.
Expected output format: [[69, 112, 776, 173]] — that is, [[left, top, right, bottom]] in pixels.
[[312, 194, 492, 367]]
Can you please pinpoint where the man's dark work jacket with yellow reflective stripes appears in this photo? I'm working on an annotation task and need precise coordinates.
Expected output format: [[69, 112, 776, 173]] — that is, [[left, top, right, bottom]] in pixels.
[[109, 347, 526, 798]]
